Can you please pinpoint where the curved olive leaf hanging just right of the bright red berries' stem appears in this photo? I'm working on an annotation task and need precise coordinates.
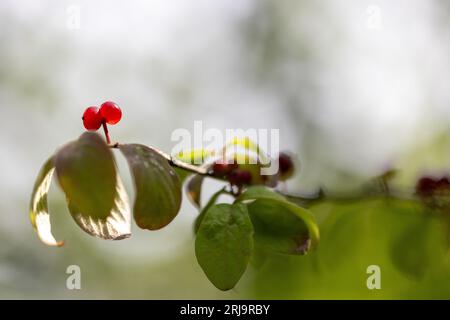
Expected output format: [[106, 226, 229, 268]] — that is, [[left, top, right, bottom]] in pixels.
[[119, 144, 181, 230]]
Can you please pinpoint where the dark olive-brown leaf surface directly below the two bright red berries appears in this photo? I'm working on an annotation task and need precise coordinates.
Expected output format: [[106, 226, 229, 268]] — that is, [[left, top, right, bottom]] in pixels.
[[55, 132, 116, 219]]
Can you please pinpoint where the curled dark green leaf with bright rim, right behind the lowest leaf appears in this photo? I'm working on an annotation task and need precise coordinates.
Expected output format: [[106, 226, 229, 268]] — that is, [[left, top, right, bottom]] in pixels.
[[236, 186, 319, 254]]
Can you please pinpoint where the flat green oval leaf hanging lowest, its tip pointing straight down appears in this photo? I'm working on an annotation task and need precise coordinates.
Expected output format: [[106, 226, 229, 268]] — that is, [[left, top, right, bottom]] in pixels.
[[195, 203, 253, 290]]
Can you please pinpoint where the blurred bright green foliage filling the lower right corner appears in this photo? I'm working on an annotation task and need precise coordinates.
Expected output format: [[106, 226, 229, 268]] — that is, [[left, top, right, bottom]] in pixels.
[[253, 198, 450, 299]]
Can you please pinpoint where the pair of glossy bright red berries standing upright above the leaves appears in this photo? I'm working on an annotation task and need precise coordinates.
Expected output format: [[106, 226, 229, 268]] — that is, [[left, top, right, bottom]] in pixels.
[[82, 101, 122, 131]]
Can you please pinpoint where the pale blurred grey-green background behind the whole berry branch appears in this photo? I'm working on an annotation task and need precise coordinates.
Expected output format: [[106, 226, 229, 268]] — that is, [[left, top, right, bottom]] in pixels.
[[0, 0, 450, 299]]
